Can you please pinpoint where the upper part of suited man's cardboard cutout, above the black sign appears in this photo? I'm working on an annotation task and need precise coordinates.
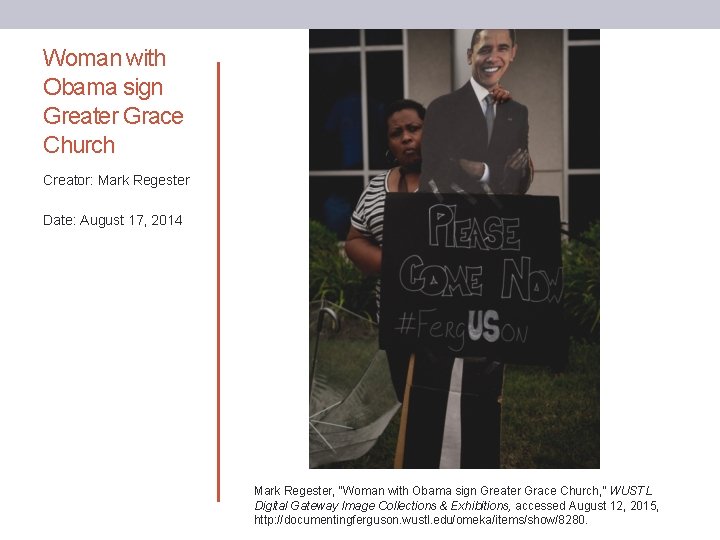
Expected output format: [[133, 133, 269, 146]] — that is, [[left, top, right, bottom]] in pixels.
[[420, 30, 532, 195]]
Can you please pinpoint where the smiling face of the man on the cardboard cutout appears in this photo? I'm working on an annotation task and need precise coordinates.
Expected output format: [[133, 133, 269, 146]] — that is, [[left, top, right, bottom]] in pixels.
[[467, 30, 517, 90]]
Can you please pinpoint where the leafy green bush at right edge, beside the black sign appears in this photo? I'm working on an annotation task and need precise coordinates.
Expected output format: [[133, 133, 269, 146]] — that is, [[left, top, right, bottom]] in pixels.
[[563, 222, 600, 341]]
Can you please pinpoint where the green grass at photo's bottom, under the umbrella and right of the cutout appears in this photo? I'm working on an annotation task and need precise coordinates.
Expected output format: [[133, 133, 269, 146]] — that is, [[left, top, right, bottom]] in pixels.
[[318, 342, 600, 469]]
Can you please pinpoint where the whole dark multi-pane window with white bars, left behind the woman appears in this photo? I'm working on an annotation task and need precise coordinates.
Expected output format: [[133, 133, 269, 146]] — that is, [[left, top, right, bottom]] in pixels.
[[309, 30, 405, 240]]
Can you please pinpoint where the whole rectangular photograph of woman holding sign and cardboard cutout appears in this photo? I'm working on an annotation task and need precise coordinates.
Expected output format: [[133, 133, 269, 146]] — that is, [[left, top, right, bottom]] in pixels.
[[309, 29, 600, 469]]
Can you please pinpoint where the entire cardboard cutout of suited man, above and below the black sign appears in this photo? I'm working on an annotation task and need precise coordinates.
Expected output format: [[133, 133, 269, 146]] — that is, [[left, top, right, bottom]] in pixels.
[[394, 30, 532, 468]]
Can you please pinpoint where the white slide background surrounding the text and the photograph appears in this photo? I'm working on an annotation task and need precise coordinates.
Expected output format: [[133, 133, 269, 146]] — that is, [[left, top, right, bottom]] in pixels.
[[0, 30, 720, 538]]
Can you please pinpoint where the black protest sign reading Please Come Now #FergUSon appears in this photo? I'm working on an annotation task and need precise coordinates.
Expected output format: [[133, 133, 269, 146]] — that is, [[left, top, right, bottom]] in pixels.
[[380, 193, 567, 365]]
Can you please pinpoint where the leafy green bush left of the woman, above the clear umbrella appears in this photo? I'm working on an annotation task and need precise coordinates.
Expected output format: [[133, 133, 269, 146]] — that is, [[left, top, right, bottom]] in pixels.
[[310, 221, 376, 314]]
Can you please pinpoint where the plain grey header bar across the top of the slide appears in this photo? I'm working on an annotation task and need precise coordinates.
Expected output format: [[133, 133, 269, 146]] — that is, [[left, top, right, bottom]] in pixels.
[[0, 0, 720, 29]]
